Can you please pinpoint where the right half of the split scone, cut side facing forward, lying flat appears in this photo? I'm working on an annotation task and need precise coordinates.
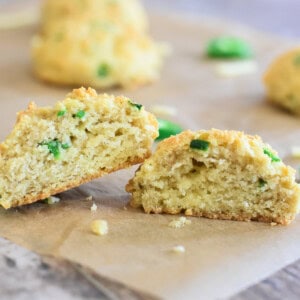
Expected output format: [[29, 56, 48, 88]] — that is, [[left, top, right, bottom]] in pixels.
[[126, 129, 300, 224]]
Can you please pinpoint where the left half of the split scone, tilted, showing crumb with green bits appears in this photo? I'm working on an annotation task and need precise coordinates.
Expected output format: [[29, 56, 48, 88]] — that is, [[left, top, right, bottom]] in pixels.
[[0, 88, 158, 208]]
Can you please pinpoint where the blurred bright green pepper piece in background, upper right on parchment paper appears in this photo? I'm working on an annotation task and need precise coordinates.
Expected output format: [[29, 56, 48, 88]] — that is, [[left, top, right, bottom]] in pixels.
[[206, 36, 253, 58]]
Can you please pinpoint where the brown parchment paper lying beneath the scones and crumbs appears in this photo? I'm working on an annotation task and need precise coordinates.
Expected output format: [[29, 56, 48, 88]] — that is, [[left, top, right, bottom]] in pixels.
[[0, 15, 300, 299]]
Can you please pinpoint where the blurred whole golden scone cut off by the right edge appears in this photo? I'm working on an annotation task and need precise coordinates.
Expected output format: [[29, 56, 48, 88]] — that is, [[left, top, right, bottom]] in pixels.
[[264, 48, 300, 115]]
